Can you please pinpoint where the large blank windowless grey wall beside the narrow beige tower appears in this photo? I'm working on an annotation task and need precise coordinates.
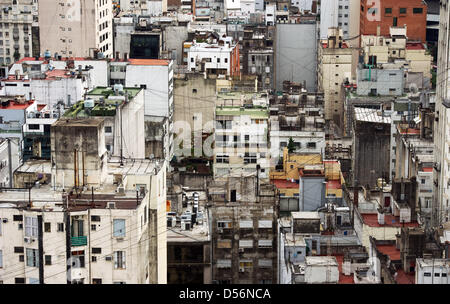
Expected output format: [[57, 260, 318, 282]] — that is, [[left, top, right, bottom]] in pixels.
[[275, 23, 317, 91]]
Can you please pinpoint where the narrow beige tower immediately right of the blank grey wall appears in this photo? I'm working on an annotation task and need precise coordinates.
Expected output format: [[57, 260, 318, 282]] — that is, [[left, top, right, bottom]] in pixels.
[[318, 27, 354, 126]]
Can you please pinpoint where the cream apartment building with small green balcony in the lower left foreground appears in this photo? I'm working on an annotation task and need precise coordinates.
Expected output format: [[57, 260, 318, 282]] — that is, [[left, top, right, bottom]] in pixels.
[[0, 161, 167, 284]]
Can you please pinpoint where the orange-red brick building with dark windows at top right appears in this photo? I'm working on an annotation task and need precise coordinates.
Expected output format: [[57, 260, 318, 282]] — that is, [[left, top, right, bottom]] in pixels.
[[360, 0, 427, 42]]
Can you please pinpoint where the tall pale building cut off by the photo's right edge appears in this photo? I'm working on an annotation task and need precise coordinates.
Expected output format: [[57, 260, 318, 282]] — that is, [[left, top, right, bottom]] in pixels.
[[432, 1, 450, 227]]
